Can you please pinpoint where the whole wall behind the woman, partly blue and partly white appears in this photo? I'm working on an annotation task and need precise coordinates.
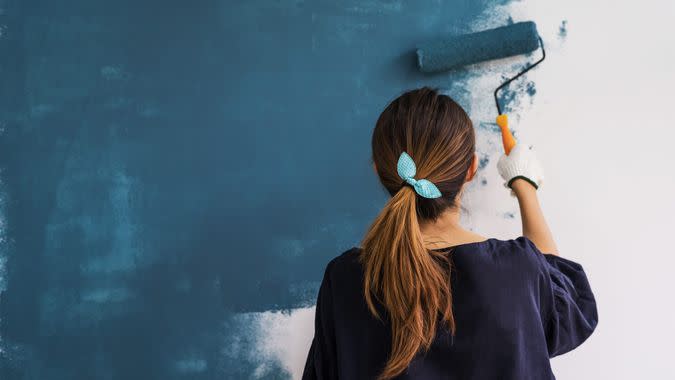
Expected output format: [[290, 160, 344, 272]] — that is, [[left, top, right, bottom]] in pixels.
[[0, 0, 675, 380]]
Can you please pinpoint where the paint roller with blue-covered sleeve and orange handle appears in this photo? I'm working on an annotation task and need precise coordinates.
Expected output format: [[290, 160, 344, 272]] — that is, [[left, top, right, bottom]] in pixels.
[[417, 21, 546, 155]]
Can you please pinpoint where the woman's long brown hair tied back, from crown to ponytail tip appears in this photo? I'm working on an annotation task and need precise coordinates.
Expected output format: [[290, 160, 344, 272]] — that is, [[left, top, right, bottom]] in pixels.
[[359, 87, 475, 379]]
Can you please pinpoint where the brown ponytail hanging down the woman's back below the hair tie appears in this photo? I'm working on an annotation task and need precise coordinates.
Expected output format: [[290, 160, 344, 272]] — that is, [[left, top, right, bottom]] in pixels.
[[359, 186, 455, 380]]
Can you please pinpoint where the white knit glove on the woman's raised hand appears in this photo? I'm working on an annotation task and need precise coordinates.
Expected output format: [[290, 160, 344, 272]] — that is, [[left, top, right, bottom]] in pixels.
[[497, 142, 544, 196]]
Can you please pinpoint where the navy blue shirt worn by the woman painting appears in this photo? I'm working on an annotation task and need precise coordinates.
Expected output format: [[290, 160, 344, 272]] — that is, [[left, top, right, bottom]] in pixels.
[[302, 236, 598, 380]]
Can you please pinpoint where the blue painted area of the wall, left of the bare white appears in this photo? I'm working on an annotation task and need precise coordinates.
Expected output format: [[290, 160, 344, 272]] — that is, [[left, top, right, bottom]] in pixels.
[[0, 0, 508, 380]]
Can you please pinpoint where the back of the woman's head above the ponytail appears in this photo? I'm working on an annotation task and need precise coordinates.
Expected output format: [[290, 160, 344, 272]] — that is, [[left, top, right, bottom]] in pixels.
[[372, 87, 477, 220]]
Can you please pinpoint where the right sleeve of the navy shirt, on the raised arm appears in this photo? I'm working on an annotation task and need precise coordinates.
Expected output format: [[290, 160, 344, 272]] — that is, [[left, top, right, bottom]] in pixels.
[[528, 239, 598, 358]]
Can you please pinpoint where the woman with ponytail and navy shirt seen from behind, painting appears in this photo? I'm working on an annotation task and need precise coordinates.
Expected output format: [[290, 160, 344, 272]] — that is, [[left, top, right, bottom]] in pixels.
[[303, 88, 598, 380]]
